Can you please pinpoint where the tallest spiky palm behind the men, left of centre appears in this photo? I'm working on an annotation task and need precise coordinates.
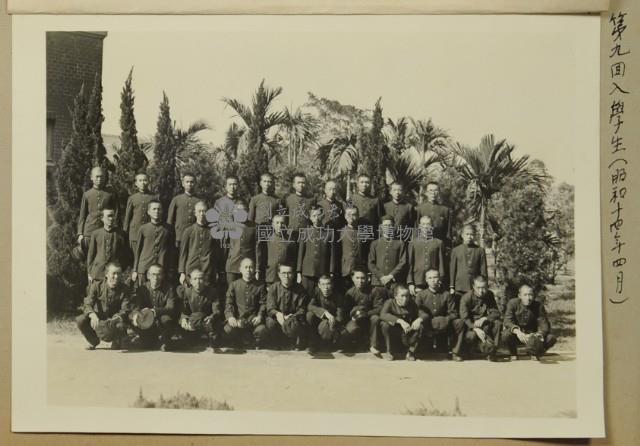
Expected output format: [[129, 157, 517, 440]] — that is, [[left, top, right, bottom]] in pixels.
[[222, 79, 286, 166]]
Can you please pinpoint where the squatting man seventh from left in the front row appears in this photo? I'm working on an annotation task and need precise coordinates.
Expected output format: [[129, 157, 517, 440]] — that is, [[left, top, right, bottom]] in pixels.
[[343, 267, 382, 355]]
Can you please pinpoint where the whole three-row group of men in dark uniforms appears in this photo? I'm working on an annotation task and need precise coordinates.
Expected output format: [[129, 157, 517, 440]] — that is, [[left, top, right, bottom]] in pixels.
[[76, 167, 555, 361]]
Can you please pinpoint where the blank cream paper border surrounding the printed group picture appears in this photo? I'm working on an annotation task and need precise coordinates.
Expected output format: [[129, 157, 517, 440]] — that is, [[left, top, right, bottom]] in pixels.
[[12, 12, 604, 438]]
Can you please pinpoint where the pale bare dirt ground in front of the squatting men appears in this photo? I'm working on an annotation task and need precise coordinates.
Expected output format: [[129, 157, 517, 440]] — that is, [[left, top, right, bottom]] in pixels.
[[48, 334, 576, 417]]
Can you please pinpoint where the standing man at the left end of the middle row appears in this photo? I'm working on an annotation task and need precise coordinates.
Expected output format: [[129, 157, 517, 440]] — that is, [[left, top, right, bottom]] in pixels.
[[87, 208, 127, 283]]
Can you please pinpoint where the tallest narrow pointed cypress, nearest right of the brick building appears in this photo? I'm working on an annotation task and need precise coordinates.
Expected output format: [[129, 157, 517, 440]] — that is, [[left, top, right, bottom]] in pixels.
[[112, 68, 147, 216]]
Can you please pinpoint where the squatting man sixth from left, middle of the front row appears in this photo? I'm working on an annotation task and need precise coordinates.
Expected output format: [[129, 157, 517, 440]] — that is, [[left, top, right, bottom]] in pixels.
[[307, 275, 347, 349]]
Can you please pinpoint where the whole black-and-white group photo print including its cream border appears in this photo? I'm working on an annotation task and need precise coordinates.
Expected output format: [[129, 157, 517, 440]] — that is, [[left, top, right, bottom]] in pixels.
[[13, 16, 604, 438]]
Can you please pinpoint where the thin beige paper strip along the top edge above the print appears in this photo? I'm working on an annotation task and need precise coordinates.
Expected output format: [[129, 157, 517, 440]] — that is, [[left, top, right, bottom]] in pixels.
[[7, 0, 609, 14]]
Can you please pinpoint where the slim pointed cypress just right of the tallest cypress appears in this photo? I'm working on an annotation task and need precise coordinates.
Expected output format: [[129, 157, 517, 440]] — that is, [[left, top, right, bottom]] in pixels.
[[151, 91, 177, 209]]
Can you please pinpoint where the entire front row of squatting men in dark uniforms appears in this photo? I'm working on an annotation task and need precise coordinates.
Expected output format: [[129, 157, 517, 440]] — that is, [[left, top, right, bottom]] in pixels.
[[76, 258, 555, 361]]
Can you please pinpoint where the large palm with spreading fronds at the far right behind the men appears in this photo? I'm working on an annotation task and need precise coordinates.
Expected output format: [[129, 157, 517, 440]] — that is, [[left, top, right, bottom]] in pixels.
[[451, 135, 548, 247]]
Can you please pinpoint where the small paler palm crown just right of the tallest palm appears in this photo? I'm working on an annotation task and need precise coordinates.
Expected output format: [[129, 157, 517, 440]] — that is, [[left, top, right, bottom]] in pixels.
[[276, 107, 320, 166]]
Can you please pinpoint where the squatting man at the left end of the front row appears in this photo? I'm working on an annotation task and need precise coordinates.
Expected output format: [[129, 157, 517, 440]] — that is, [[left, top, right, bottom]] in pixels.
[[76, 263, 131, 350]]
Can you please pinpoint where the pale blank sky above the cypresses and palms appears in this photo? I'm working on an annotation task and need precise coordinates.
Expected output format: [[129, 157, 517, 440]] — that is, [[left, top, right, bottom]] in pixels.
[[97, 18, 597, 183]]
